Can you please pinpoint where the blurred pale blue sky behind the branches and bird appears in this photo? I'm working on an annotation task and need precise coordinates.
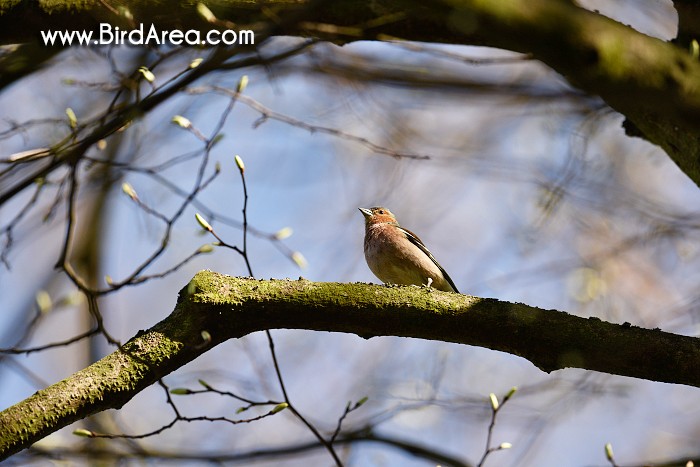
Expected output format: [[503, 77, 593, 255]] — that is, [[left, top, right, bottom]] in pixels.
[[0, 6, 700, 466]]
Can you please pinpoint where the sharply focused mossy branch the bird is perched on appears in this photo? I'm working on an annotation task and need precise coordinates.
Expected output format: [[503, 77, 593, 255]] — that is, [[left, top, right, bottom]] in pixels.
[[0, 271, 700, 459]]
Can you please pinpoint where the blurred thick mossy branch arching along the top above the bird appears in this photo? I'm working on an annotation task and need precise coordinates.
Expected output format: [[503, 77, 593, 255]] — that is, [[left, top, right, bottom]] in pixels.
[[0, 0, 700, 185]]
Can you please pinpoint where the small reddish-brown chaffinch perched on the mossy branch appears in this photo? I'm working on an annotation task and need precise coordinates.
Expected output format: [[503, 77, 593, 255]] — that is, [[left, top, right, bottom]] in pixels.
[[359, 207, 459, 293]]
